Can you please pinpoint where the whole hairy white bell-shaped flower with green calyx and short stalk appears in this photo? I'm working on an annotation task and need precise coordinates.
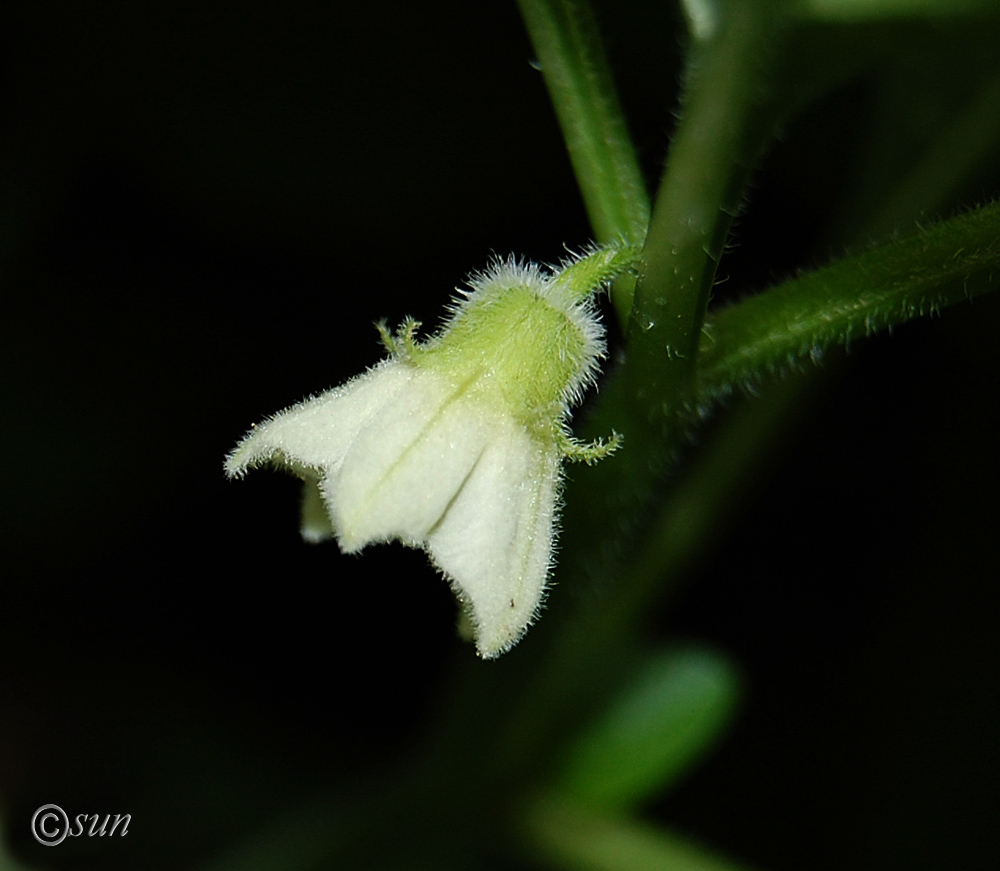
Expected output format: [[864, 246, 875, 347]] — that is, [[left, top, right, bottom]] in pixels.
[[225, 246, 637, 658]]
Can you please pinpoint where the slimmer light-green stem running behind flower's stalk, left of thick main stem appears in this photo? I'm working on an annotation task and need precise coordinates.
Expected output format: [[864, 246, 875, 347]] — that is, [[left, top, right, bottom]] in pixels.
[[518, 0, 649, 325]]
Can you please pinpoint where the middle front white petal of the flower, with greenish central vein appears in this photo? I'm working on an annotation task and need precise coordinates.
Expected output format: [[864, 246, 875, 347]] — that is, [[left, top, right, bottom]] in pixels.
[[330, 370, 493, 553]]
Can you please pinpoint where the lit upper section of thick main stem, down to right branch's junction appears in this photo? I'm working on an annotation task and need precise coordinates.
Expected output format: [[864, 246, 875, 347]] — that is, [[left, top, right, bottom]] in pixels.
[[628, 2, 786, 413]]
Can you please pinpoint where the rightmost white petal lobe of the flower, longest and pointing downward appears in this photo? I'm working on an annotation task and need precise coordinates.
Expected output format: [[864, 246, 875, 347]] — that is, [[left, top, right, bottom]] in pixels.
[[427, 422, 559, 659]]
